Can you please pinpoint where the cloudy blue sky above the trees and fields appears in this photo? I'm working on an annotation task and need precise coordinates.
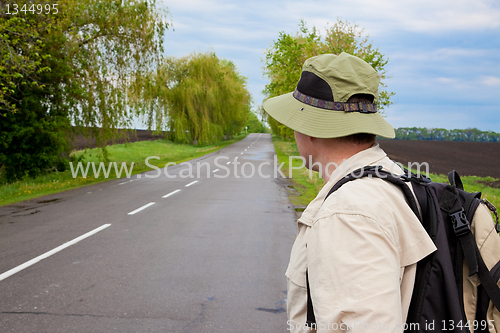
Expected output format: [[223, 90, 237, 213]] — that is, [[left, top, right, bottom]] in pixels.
[[153, 0, 500, 132]]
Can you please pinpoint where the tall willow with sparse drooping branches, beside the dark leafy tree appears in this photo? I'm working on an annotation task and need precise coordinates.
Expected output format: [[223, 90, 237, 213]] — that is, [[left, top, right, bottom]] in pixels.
[[54, 0, 168, 144]]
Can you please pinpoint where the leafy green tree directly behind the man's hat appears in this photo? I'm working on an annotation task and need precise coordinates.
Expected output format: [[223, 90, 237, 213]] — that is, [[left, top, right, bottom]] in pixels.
[[264, 19, 394, 138]]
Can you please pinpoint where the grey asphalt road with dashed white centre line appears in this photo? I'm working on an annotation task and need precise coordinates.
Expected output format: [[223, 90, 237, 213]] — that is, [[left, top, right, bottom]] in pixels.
[[0, 134, 296, 333]]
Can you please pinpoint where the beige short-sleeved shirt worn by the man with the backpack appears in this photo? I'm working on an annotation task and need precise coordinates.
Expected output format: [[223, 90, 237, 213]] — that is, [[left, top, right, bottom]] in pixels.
[[286, 144, 436, 332]]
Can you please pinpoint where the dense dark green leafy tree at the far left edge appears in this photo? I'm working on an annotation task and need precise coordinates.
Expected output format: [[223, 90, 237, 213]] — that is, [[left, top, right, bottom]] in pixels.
[[0, 5, 69, 180]]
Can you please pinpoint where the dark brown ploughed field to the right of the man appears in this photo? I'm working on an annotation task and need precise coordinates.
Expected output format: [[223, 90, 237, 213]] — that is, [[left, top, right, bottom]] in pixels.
[[379, 140, 500, 179]]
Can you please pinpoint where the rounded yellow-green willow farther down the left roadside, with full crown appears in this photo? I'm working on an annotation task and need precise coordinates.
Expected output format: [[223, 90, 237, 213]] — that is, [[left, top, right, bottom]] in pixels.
[[133, 53, 250, 145]]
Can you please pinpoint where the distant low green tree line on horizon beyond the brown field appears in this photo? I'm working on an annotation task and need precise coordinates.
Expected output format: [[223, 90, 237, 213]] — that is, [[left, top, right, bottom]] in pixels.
[[395, 127, 500, 142]]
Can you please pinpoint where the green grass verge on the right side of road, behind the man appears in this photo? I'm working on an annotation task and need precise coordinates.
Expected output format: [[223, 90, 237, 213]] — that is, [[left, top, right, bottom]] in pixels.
[[273, 136, 500, 211]]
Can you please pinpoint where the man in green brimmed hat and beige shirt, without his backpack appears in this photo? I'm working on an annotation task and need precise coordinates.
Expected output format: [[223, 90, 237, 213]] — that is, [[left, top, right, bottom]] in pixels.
[[264, 53, 435, 332]]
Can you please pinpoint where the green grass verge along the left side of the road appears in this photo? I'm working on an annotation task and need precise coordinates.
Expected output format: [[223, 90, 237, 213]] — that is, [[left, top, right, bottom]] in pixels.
[[0, 134, 246, 206]]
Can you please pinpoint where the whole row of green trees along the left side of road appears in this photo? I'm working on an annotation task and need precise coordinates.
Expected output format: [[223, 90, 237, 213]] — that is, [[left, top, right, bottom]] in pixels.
[[0, 0, 258, 180]]
